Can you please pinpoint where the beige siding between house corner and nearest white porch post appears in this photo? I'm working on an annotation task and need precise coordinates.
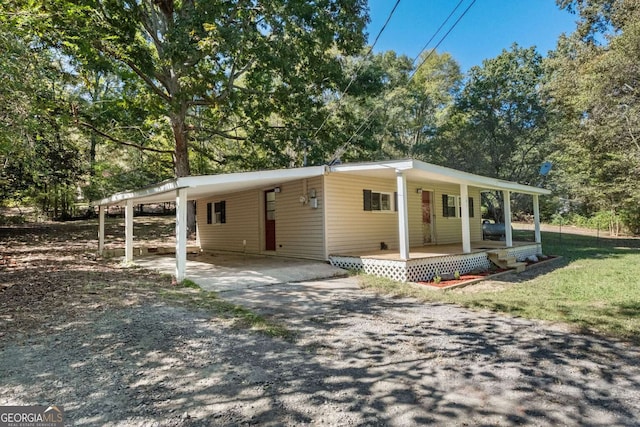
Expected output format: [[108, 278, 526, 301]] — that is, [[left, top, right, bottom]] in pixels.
[[325, 174, 398, 255]]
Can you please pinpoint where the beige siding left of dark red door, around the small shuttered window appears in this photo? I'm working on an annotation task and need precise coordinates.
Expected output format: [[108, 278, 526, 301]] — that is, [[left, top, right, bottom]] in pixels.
[[197, 191, 261, 253]]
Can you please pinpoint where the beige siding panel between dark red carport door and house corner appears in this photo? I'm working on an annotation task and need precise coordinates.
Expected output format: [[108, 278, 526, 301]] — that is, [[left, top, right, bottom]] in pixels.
[[276, 177, 326, 260]]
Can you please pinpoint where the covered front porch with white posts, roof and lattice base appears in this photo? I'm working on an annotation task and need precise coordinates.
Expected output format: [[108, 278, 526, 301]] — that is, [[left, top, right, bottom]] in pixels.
[[329, 159, 551, 282]]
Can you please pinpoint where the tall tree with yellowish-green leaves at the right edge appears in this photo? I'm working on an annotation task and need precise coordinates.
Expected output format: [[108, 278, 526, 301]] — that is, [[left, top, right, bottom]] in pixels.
[[547, 1, 640, 233]]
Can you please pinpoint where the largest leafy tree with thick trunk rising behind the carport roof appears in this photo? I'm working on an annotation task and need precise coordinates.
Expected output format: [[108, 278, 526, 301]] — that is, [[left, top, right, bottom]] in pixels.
[[10, 0, 366, 231]]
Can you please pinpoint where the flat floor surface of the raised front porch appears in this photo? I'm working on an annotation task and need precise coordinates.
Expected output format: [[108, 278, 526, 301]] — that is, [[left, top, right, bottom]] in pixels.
[[332, 240, 536, 261]]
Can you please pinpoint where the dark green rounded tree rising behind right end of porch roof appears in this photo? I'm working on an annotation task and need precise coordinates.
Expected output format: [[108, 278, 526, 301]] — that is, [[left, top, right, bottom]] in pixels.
[[434, 44, 551, 220]]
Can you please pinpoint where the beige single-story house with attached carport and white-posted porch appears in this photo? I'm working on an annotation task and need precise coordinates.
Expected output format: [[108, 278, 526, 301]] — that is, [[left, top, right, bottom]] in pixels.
[[93, 159, 550, 281]]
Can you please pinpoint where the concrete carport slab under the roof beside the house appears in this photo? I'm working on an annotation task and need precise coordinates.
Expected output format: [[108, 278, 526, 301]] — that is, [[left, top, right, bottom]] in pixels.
[[134, 253, 347, 292]]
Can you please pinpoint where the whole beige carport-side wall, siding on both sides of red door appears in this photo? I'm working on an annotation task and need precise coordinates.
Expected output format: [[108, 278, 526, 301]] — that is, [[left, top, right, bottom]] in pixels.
[[197, 177, 325, 260]]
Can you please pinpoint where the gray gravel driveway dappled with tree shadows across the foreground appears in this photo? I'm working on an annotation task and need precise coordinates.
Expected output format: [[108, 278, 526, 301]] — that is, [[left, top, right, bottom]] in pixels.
[[0, 299, 640, 426]]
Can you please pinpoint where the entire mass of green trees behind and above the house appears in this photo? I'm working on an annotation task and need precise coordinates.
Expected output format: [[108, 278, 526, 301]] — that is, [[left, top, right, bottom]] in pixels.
[[0, 0, 640, 236]]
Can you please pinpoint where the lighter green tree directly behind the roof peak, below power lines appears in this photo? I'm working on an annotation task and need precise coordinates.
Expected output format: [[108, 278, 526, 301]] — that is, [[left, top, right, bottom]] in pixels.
[[324, 51, 462, 161]]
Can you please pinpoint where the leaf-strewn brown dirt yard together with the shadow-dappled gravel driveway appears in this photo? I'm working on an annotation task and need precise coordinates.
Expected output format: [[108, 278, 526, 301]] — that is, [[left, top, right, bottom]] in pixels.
[[0, 220, 640, 426]]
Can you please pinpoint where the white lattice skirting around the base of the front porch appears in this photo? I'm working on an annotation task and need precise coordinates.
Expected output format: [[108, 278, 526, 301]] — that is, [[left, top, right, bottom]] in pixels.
[[329, 244, 542, 282]]
